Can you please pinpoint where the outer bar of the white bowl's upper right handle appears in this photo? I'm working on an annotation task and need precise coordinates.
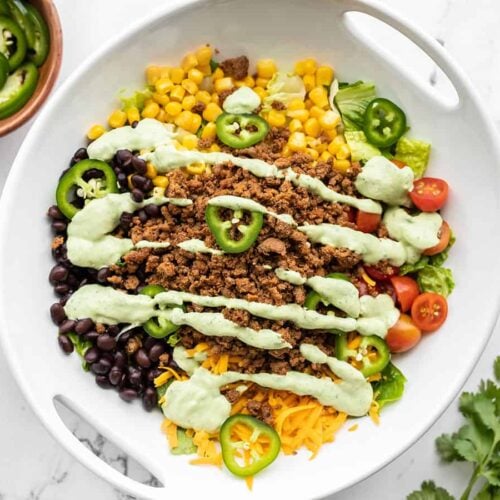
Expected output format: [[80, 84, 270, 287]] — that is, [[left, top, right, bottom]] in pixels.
[[341, 0, 473, 111]]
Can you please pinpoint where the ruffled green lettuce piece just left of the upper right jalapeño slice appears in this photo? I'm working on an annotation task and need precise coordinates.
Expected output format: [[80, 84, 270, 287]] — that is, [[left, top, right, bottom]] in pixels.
[[334, 81, 377, 132]]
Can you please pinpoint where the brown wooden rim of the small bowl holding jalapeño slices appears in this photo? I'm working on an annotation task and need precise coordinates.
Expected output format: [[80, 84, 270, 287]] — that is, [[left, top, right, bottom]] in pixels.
[[0, 0, 64, 137]]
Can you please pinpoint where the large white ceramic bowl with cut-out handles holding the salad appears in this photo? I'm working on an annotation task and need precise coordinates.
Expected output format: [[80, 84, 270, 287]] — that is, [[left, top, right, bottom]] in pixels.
[[0, 0, 500, 500]]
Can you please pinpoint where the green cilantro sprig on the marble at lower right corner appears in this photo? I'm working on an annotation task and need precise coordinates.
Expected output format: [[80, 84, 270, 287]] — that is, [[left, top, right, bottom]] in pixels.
[[407, 356, 500, 500]]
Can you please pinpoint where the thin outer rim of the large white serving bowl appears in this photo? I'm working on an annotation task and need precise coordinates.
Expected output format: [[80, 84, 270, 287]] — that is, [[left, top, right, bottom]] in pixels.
[[0, 0, 500, 498]]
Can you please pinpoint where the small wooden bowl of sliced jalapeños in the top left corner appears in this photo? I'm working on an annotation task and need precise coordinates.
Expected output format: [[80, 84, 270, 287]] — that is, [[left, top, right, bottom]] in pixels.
[[0, 0, 63, 137]]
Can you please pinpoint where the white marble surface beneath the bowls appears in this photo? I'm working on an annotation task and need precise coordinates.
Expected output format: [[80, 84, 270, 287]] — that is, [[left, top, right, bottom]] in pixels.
[[0, 0, 500, 500]]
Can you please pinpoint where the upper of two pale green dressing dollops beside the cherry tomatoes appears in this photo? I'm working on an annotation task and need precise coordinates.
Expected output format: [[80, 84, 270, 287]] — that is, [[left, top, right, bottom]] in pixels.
[[354, 156, 414, 205]]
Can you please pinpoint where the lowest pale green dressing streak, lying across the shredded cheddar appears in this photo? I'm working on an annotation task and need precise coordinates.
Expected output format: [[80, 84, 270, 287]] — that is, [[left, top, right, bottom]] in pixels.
[[162, 344, 373, 432]]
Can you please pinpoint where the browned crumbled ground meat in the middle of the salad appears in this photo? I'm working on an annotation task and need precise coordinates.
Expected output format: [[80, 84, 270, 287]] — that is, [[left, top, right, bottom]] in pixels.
[[108, 131, 366, 384]]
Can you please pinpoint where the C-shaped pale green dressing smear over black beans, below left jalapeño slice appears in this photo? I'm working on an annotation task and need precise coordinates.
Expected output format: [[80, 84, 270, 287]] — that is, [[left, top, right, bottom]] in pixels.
[[66, 193, 192, 269]]
